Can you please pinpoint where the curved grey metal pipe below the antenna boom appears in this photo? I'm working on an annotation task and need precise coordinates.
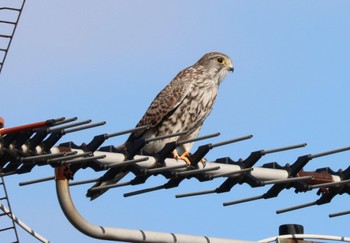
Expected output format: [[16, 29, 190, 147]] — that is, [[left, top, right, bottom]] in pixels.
[[56, 167, 251, 243]]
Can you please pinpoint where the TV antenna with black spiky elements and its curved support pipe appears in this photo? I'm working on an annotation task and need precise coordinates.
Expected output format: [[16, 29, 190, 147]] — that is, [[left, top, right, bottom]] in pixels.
[[0, 117, 350, 243]]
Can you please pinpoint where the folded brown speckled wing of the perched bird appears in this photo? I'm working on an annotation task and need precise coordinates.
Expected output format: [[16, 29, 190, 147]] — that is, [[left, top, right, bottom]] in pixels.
[[128, 68, 193, 140]]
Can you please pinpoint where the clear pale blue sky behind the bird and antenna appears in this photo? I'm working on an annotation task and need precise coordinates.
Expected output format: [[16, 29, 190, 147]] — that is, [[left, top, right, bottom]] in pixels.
[[0, 0, 350, 243]]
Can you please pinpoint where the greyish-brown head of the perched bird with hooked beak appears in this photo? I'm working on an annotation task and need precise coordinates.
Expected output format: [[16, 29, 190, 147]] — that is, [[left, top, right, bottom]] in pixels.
[[196, 52, 234, 82]]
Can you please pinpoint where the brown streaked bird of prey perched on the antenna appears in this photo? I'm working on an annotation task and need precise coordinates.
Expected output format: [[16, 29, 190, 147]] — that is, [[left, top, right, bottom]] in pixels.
[[87, 52, 234, 200]]
